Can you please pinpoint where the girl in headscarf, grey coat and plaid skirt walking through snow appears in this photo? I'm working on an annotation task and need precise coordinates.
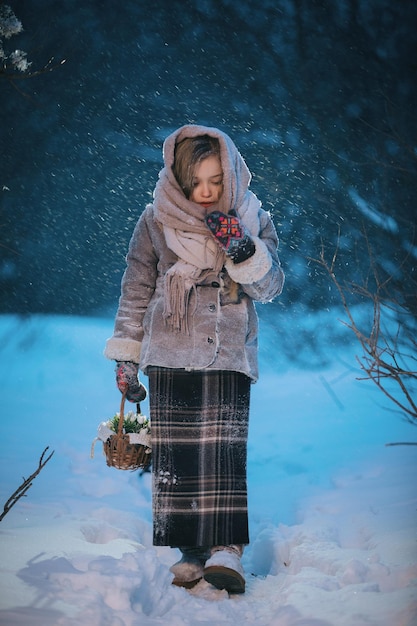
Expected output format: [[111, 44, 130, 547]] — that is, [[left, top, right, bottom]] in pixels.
[[105, 125, 284, 593]]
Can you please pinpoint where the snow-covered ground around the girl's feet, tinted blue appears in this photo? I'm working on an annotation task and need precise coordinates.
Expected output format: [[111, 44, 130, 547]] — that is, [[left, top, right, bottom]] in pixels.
[[0, 313, 417, 626]]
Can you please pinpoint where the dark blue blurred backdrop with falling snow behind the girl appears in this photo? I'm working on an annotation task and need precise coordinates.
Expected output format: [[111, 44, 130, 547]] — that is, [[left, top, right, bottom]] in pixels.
[[0, 0, 417, 315]]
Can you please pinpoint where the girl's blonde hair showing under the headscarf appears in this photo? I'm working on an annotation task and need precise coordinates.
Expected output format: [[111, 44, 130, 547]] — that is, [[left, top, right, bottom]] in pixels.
[[172, 135, 220, 198]]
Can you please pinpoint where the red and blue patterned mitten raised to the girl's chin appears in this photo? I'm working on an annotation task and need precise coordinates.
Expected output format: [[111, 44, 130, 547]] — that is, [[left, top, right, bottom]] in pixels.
[[206, 211, 255, 264]]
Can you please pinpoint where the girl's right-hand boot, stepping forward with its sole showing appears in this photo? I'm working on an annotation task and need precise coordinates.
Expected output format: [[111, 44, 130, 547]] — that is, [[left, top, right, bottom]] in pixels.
[[204, 545, 245, 593]]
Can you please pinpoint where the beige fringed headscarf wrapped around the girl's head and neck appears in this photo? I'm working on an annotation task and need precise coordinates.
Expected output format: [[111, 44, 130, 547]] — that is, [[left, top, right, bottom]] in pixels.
[[153, 125, 260, 333]]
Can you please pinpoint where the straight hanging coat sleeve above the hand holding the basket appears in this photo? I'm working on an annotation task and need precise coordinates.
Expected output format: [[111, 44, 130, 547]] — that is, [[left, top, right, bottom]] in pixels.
[[104, 210, 158, 363]]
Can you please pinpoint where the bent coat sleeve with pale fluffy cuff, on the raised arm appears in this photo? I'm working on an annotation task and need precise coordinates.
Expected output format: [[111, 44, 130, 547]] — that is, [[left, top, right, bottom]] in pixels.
[[226, 209, 285, 303]]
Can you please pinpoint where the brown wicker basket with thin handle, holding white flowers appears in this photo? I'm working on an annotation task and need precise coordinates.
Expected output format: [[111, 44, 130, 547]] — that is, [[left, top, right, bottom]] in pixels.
[[103, 392, 152, 470]]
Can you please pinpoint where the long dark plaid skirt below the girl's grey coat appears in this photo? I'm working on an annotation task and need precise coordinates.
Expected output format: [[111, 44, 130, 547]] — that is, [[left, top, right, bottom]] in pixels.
[[148, 367, 250, 547]]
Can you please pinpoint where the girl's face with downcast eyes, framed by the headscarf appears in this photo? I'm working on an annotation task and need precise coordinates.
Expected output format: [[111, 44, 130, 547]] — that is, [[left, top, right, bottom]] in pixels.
[[190, 156, 223, 209]]
